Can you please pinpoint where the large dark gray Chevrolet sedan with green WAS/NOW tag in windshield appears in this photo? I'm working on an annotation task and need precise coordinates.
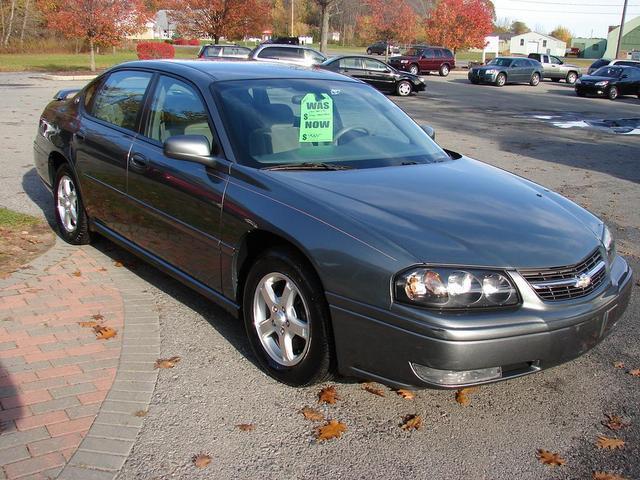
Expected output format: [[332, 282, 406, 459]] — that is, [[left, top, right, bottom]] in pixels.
[[34, 61, 632, 388]]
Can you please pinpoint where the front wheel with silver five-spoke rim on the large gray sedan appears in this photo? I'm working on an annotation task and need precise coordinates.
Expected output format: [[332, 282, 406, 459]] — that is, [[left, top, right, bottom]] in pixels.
[[242, 248, 333, 387]]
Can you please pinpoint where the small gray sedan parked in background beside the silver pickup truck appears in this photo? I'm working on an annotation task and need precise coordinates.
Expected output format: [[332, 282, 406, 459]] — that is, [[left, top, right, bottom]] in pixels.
[[468, 57, 544, 87]]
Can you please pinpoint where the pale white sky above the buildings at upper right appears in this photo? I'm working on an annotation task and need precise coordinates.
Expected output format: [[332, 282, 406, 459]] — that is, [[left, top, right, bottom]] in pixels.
[[493, 0, 640, 38]]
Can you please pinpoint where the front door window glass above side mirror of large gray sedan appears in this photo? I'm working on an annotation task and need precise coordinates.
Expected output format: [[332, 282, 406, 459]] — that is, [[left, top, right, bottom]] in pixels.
[[145, 76, 213, 145]]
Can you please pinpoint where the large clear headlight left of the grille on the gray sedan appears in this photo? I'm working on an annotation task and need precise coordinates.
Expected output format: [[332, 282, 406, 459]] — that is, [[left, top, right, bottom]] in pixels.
[[395, 267, 520, 309]]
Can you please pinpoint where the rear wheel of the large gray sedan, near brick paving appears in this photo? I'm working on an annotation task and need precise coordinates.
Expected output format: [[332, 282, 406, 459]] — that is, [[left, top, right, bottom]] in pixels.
[[53, 163, 91, 245]]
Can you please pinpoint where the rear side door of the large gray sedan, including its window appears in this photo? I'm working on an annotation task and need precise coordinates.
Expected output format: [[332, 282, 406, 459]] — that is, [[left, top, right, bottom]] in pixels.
[[72, 70, 153, 236]]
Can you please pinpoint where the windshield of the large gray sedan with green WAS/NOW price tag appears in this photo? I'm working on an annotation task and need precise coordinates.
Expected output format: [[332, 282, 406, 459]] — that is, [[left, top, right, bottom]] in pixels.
[[212, 78, 450, 168]]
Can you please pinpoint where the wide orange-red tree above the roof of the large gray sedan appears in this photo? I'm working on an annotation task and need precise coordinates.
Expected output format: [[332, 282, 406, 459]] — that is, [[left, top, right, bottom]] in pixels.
[[170, 0, 271, 43]]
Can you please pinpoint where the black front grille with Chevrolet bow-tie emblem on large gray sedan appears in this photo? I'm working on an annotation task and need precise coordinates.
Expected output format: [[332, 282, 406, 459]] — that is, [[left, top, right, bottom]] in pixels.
[[520, 249, 607, 301]]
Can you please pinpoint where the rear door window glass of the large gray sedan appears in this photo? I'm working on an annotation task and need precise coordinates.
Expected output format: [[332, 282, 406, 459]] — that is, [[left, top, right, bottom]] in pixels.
[[91, 70, 152, 131]]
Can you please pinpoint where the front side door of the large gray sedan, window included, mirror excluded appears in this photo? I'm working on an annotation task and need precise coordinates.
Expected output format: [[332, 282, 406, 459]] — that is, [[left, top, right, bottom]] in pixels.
[[127, 75, 229, 291]]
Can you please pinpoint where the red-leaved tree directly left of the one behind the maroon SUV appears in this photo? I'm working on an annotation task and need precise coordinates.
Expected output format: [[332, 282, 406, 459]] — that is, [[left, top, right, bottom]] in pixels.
[[358, 0, 420, 50]]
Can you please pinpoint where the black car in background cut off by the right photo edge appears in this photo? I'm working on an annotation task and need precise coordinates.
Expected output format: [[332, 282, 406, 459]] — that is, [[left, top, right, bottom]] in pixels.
[[575, 65, 640, 100]]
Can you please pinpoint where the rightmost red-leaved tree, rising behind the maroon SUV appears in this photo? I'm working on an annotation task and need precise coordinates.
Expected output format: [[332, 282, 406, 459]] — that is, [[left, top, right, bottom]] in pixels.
[[426, 0, 494, 52]]
